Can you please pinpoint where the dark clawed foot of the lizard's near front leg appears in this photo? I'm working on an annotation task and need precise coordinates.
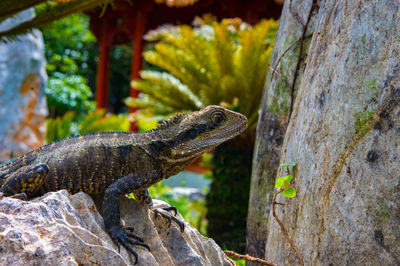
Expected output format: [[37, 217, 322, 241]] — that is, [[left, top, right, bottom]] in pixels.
[[108, 226, 150, 264]]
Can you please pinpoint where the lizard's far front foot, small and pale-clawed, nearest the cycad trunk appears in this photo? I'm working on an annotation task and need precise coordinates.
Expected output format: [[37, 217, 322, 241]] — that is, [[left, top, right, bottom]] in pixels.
[[133, 189, 185, 233]]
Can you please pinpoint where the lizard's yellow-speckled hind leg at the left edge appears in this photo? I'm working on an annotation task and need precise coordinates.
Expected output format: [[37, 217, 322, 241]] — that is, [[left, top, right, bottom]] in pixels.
[[0, 164, 49, 199]]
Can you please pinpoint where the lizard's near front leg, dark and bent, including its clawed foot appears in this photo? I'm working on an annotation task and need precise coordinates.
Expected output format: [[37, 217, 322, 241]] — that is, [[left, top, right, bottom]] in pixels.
[[103, 174, 150, 264]]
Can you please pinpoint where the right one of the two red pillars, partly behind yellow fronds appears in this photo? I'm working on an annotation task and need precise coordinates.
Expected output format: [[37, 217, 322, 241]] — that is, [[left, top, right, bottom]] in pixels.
[[129, 8, 147, 131]]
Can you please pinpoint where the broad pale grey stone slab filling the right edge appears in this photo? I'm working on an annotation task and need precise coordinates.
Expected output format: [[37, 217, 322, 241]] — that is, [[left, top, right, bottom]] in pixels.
[[265, 0, 400, 265]]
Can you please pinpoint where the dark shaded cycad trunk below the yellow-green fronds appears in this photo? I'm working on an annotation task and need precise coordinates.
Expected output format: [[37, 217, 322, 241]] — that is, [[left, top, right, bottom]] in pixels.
[[206, 132, 254, 253]]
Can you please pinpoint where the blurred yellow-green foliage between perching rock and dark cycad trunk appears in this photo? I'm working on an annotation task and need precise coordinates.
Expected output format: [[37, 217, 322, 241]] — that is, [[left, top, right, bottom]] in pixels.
[[129, 182, 207, 235]]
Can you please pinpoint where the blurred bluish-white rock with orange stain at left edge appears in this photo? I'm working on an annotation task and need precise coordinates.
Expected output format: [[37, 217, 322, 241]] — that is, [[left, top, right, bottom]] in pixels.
[[0, 9, 47, 162]]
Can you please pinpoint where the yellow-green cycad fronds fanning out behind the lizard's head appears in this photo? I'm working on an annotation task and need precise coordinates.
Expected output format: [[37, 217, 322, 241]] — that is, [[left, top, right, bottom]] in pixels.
[[126, 19, 278, 128]]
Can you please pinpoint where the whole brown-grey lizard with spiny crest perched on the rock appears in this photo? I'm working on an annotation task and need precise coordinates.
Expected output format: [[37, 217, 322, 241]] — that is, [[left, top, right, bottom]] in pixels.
[[0, 105, 247, 264]]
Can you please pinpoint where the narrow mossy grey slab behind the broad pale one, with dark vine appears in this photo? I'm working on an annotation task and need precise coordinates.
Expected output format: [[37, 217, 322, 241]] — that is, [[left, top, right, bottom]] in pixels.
[[246, 0, 317, 258]]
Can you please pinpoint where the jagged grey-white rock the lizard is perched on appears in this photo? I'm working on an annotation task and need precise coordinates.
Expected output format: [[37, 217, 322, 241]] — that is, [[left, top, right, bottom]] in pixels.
[[0, 190, 231, 265]]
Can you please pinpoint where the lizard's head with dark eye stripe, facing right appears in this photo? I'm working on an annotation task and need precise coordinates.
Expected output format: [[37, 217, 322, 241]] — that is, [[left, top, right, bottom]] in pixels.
[[156, 105, 247, 160]]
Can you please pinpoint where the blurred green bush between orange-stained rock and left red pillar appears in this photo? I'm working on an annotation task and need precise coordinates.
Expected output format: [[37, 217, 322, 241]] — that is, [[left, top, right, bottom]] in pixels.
[[42, 14, 97, 118]]
